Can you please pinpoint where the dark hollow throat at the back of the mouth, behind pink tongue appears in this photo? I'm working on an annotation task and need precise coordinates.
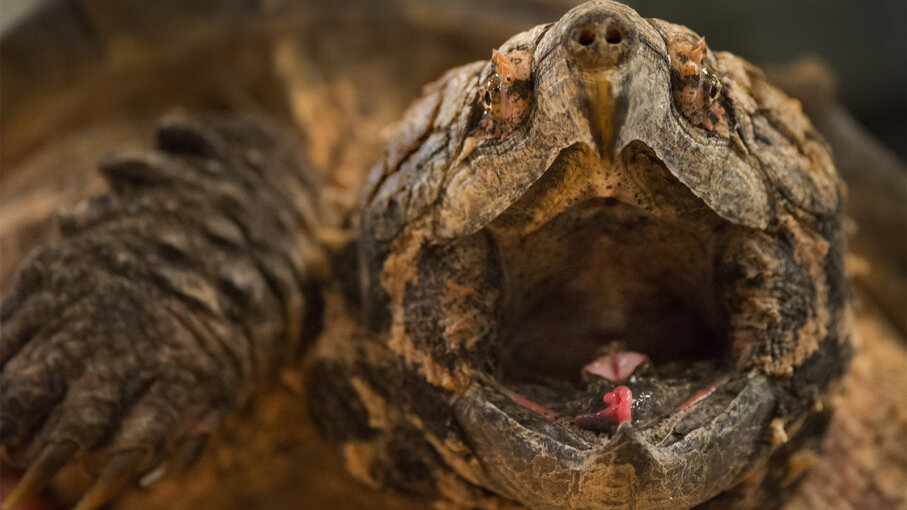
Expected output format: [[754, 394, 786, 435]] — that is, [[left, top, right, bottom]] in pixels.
[[502, 199, 724, 383]]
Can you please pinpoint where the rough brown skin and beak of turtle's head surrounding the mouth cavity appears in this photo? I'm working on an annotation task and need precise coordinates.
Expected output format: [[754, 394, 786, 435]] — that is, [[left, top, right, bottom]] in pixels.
[[312, 2, 850, 508]]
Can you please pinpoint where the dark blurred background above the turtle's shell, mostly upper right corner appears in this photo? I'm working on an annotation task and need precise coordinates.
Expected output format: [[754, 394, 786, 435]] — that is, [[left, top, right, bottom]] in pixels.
[[0, 0, 907, 159]]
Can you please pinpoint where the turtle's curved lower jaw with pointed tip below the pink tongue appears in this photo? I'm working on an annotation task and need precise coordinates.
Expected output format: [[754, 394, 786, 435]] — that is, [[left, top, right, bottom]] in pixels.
[[454, 373, 775, 509]]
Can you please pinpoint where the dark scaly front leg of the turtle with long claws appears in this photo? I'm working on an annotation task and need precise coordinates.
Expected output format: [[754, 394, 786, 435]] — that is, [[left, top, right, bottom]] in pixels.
[[0, 116, 322, 510]]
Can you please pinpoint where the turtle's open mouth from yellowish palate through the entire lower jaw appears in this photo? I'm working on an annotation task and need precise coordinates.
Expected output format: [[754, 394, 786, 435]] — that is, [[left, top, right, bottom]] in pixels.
[[442, 139, 777, 508]]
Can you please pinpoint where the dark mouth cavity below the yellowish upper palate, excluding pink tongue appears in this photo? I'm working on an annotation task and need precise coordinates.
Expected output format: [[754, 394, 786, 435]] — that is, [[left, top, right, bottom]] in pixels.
[[496, 152, 743, 443]]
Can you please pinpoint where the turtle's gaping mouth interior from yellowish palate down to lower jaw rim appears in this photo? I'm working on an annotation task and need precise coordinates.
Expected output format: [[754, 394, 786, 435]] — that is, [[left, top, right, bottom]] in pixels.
[[464, 139, 772, 454]]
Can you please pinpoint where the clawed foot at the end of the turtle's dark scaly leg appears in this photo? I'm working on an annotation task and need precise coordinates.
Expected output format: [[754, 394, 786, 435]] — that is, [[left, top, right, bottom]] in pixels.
[[0, 246, 238, 510]]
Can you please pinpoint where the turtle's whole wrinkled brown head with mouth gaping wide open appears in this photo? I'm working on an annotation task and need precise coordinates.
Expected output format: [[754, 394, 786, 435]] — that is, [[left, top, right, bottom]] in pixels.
[[319, 2, 850, 508]]
